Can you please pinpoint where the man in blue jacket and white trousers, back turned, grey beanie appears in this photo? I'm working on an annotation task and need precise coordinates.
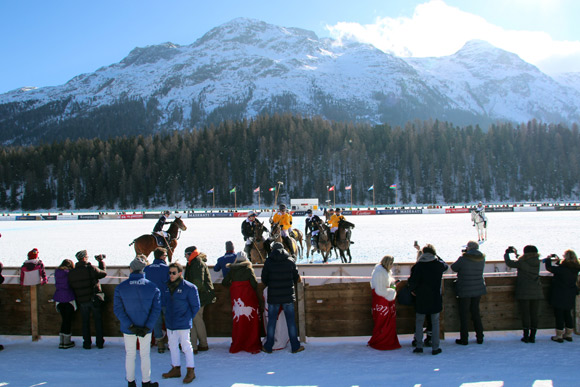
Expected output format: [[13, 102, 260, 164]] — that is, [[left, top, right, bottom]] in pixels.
[[114, 255, 161, 387]]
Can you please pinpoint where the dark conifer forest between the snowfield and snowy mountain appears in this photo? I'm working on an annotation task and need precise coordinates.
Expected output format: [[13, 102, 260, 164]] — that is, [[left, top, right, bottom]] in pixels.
[[0, 114, 580, 211]]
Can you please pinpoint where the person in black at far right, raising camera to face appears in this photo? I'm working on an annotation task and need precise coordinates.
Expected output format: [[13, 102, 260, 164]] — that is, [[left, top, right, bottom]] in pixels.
[[544, 250, 580, 343]]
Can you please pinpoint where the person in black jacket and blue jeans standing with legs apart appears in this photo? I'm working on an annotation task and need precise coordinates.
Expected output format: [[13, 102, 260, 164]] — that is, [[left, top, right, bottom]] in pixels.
[[262, 242, 304, 353]]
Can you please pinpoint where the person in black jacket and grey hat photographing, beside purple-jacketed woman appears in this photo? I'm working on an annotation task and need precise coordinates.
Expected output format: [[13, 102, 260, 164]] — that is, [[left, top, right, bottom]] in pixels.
[[68, 250, 107, 349]]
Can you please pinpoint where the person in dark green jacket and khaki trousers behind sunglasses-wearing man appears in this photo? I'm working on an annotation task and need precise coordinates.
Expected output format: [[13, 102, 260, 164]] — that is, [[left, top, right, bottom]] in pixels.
[[183, 246, 216, 353]]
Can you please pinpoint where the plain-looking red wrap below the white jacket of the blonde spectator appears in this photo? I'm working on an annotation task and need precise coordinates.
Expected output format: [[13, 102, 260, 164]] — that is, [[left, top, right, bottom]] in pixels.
[[368, 289, 401, 351]]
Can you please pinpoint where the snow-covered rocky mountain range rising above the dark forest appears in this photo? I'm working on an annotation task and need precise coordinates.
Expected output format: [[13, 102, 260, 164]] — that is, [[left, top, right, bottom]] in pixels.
[[0, 18, 580, 144]]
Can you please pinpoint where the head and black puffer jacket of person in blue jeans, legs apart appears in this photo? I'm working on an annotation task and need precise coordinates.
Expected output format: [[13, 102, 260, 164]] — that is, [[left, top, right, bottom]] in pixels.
[[262, 242, 300, 304]]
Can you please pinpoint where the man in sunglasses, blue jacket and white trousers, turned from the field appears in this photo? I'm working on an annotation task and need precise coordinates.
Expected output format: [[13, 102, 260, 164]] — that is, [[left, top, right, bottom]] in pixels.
[[161, 262, 200, 383]]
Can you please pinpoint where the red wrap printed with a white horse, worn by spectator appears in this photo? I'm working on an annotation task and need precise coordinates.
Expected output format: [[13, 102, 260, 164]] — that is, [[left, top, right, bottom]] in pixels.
[[230, 281, 262, 353]]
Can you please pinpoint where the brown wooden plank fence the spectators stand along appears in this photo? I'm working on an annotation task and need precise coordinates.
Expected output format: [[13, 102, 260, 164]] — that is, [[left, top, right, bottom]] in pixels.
[[0, 276, 579, 340]]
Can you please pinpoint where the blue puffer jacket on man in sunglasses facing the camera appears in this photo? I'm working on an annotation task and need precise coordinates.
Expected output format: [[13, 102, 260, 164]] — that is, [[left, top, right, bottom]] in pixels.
[[161, 279, 200, 331]]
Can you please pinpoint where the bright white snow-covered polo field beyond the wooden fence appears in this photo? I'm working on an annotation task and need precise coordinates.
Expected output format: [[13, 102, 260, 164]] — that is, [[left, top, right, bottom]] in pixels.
[[0, 211, 580, 266]]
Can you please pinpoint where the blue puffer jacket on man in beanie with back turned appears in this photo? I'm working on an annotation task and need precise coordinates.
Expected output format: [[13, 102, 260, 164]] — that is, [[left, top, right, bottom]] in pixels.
[[114, 273, 161, 334]]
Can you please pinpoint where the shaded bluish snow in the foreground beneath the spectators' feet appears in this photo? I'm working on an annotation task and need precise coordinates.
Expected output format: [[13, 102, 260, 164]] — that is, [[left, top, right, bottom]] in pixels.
[[0, 330, 580, 387]]
